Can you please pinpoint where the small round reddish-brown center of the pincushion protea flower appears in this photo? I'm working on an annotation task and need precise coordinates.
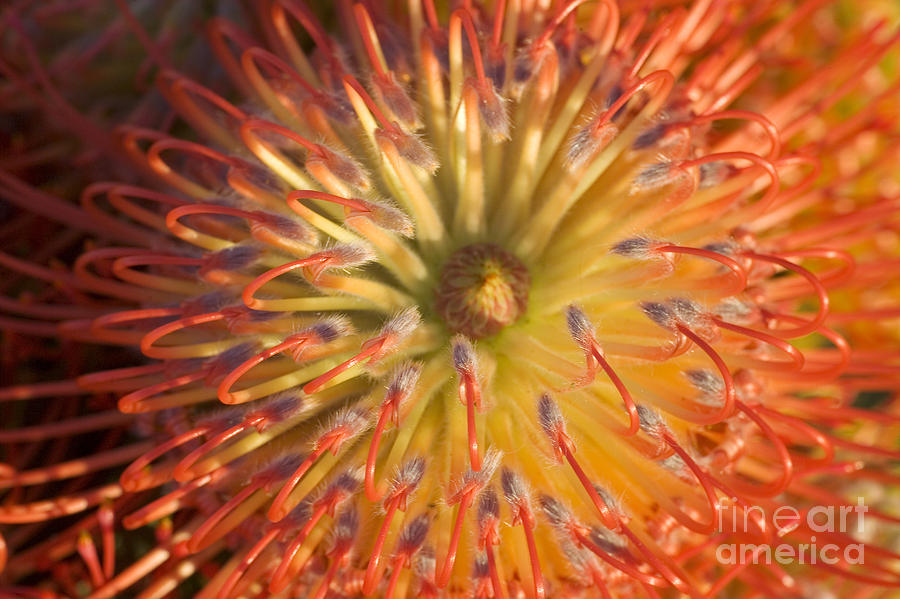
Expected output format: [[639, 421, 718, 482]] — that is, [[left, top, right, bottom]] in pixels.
[[435, 243, 531, 339]]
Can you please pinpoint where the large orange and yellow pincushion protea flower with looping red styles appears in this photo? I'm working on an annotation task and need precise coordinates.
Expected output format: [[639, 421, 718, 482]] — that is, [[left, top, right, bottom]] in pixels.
[[0, 0, 900, 598]]
